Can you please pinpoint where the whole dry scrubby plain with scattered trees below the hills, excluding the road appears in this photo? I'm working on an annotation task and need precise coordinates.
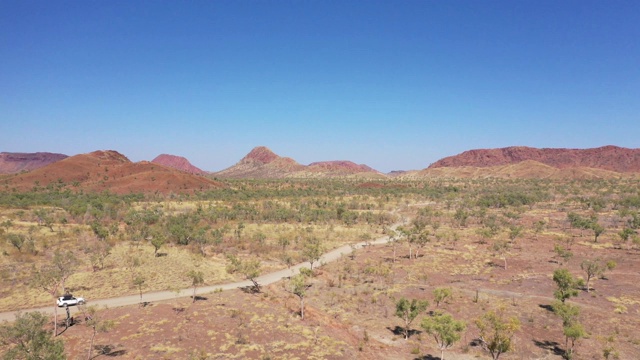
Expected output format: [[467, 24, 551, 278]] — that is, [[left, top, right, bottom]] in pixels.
[[0, 179, 640, 359]]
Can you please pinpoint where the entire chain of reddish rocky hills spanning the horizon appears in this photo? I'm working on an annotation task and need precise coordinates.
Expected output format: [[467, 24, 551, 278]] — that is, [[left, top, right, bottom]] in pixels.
[[0, 146, 640, 193]]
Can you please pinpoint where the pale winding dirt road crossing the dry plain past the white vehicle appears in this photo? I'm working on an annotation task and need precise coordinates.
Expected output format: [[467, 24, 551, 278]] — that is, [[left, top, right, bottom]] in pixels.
[[0, 223, 401, 321]]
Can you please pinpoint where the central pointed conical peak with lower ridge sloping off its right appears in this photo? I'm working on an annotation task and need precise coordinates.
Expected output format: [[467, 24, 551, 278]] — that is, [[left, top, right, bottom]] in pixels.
[[213, 146, 385, 179]]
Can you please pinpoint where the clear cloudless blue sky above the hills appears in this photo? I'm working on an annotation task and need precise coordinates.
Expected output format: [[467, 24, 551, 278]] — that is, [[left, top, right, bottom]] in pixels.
[[0, 0, 640, 172]]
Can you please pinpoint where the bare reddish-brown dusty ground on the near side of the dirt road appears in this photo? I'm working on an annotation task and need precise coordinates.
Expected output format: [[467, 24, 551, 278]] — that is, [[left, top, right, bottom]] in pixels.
[[53, 221, 640, 359]]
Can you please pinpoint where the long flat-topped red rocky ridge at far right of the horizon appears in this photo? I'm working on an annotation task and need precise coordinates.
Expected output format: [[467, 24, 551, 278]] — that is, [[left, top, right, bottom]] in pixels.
[[429, 145, 640, 173]]
